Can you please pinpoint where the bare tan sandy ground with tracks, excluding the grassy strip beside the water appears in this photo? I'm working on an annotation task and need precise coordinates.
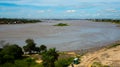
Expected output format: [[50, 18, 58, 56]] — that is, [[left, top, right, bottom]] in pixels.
[[69, 46, 120, 67]]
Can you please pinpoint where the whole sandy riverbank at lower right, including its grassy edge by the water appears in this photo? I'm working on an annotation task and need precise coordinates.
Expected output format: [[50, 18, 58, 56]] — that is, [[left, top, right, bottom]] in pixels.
[[70, 41, 120, 67]]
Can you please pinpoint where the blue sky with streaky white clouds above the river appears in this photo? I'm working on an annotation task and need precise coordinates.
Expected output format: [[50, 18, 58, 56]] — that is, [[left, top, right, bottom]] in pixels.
[[0, 0, 120, 19]]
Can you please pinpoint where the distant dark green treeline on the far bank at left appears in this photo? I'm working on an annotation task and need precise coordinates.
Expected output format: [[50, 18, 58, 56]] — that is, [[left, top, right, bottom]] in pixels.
[[0, 18, 41, 24]]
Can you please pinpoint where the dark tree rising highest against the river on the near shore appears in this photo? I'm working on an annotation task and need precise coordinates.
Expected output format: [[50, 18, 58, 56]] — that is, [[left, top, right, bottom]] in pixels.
[[23, 39, 36, 54]]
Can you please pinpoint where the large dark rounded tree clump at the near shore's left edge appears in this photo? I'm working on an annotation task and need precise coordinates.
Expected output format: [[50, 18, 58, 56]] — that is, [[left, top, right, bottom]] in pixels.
[[0, 44, 23, 64]]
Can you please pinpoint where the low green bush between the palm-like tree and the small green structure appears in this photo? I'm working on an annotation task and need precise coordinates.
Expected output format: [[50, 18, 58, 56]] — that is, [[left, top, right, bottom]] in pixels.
[[55, 57, 73, 67]]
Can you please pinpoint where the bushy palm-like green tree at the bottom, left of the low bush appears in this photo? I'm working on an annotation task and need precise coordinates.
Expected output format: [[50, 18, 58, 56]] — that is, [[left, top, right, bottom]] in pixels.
[[42, 48, 59, 67]]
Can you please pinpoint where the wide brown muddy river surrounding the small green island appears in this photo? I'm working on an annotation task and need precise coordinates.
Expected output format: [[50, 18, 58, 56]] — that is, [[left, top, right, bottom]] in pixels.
[[0, 20, 120, 51]]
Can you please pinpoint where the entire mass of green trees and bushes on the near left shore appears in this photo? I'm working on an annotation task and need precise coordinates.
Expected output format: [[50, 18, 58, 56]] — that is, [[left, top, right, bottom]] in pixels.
[[0, 39, 73, 67]]
